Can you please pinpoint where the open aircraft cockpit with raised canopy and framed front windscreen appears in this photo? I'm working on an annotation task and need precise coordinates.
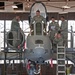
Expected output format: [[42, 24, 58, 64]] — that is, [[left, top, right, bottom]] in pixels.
[[30, 2, 47, 35]]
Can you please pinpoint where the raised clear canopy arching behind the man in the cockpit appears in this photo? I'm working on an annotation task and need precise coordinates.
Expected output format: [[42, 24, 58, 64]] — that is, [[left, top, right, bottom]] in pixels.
[[30, 2, 47, 18]]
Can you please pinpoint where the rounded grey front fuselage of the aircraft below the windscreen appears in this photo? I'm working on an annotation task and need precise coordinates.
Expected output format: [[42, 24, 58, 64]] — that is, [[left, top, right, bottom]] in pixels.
[[25, 35, 52, 61]]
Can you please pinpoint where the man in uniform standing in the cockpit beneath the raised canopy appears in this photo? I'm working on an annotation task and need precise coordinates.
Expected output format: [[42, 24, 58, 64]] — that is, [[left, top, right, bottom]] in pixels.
[[30, 10, 46, 34]]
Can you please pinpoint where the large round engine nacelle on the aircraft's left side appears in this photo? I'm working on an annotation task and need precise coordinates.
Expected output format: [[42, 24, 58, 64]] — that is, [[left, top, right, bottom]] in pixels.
[[7, 30, 25, 50]]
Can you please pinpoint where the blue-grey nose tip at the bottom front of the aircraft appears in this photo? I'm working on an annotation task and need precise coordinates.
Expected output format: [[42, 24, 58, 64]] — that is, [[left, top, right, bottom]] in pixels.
[[25, 47, 51, 64]]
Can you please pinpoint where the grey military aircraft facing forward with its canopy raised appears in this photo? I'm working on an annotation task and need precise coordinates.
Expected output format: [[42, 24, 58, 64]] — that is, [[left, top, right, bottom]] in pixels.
[[7, 2, 52, 63]]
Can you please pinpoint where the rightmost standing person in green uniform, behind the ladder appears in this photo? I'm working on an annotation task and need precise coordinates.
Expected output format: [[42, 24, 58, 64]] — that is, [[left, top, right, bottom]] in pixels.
[[60, 16, 68, 46]]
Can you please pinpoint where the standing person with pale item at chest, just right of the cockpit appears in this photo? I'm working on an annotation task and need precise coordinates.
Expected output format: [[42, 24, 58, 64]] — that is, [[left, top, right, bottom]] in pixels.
[[48, 17, 59, 48]]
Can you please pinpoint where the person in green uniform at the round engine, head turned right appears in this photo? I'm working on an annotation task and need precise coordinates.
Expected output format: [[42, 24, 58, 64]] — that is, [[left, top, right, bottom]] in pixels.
[[11, 16, 21, 47]]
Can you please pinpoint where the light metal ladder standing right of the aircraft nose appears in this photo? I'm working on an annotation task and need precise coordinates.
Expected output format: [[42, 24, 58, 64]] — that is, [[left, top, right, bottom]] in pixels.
[[57, 45, 66, 75]]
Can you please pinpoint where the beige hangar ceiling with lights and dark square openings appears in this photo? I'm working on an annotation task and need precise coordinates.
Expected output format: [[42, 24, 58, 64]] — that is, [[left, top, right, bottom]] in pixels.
[[0, 0, 75, 13]]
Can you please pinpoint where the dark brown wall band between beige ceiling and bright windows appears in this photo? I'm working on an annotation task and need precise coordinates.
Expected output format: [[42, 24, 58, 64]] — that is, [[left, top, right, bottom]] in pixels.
[[0, 12, 75, 20]]
